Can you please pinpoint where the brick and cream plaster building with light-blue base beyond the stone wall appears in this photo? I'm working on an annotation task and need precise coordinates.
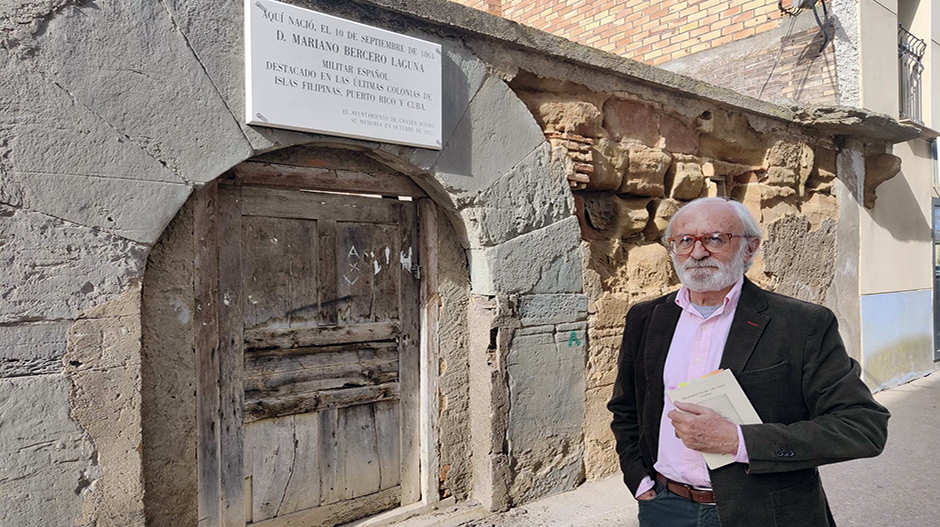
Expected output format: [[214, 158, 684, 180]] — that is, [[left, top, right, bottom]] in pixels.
[[454, 0, 940, 390]]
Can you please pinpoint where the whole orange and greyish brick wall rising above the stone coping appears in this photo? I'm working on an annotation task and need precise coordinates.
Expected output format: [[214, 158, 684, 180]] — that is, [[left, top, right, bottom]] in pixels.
[[453, 0, 838, 105]]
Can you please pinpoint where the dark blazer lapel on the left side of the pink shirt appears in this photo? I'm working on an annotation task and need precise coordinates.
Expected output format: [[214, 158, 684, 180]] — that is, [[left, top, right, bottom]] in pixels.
[[643, 293, 682, 455]]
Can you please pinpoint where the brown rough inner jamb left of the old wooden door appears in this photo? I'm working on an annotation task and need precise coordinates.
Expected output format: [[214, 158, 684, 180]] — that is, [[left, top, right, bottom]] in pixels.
[[139, 199, 199, 527]]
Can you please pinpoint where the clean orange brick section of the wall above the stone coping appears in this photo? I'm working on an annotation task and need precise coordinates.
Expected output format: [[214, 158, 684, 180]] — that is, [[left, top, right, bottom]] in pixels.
[[455, 0, 788, 65]]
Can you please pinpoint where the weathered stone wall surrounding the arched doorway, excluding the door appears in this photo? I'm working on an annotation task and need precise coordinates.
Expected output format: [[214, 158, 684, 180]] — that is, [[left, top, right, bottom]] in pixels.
[[0, 0, 911, 527]]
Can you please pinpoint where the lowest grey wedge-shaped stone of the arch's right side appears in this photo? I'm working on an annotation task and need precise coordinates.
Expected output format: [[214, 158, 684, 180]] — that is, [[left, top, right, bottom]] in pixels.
[[469, 216, 581, 295]]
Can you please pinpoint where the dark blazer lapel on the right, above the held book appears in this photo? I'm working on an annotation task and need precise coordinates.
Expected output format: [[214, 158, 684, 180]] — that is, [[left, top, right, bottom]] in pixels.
[[721, 278, 770, 376]]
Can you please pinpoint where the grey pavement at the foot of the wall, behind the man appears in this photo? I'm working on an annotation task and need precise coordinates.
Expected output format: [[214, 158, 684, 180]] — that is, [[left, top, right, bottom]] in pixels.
[[399, 372, 940, 527]]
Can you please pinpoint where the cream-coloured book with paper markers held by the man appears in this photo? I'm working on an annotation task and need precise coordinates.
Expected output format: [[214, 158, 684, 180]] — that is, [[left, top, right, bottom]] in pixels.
[[666, 370, 761, 470]]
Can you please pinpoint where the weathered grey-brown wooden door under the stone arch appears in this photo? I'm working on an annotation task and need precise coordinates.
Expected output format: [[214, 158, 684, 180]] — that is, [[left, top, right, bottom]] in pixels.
[[202, 185, 420, 527]]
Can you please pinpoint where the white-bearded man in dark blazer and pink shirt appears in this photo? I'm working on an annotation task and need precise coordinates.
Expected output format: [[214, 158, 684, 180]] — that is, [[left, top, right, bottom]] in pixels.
[[608, 198, 889, 527]]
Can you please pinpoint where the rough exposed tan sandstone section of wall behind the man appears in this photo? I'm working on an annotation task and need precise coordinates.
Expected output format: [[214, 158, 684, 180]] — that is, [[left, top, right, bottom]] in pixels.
[[511, 74, 852, 477]]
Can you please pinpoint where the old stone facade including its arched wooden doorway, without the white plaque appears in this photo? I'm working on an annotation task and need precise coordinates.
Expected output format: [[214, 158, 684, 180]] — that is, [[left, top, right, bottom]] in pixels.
[[0, 0, 922, 527]]
